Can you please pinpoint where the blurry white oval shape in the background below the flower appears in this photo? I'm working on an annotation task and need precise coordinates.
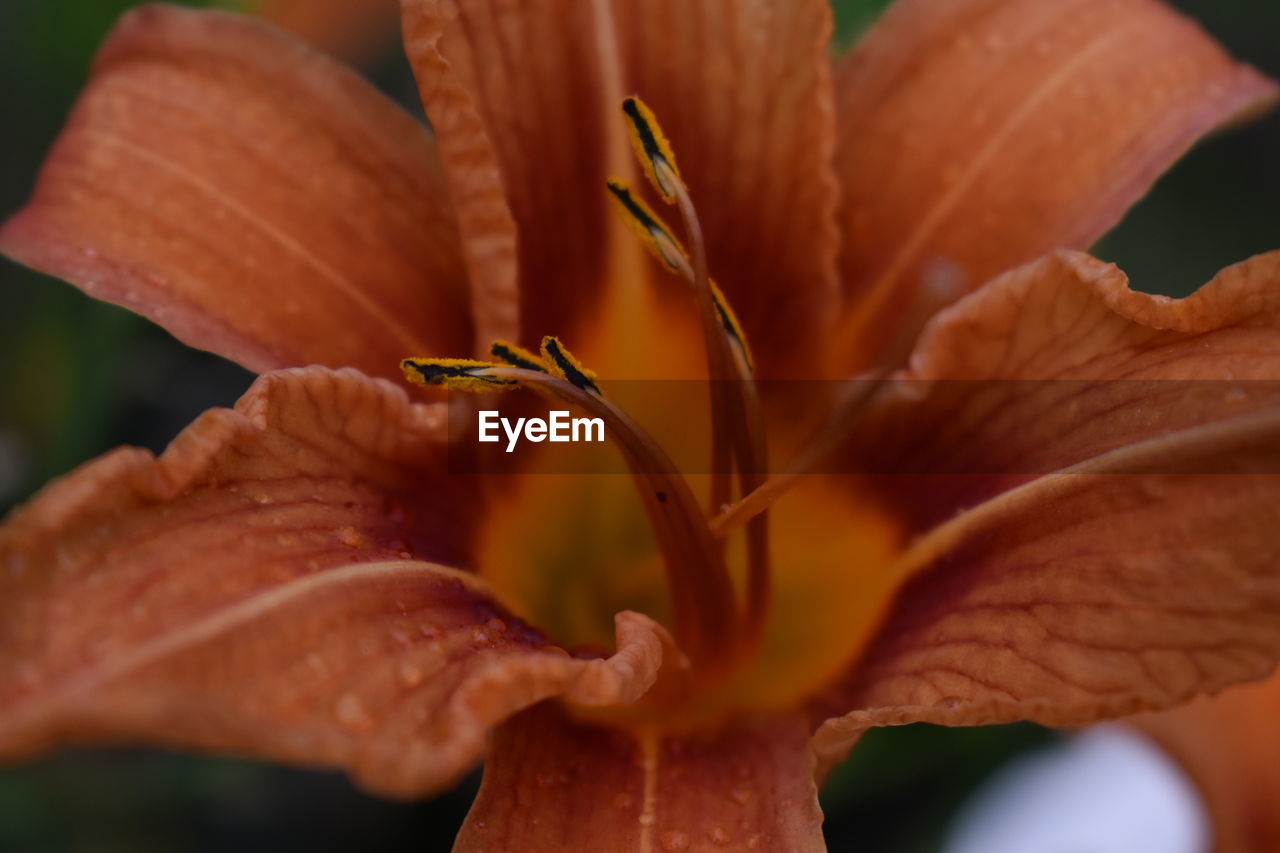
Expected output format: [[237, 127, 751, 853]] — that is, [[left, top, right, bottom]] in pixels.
[[943, 726, 1210, 853]]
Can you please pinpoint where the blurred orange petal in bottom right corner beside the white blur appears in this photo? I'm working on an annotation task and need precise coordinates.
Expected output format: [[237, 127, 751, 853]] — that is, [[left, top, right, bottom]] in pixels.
[[1133, 675, 1280, 853]]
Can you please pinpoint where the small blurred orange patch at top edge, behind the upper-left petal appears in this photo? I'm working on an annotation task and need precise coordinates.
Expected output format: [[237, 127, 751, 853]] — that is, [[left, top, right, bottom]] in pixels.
[[255, 0, 399, 61]]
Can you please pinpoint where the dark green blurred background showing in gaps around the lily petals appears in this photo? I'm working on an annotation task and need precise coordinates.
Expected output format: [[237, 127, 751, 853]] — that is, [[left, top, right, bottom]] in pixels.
[[0, 0, 1280, 853]]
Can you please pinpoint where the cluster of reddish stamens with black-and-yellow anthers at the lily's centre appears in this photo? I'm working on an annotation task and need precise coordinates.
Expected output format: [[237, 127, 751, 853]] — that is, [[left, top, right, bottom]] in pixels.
[[401, 97, 829, 675]]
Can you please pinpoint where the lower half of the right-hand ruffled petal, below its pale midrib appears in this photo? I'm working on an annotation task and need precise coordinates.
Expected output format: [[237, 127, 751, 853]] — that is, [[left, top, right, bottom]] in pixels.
[[815, 410, 1280, 766]]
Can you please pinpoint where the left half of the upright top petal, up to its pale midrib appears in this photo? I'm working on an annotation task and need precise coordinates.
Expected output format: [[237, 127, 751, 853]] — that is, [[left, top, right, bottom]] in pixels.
[[401, 0, 593, 347]]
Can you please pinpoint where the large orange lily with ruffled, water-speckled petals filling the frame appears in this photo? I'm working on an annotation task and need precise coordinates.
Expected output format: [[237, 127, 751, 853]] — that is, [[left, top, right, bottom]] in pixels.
[[0, 0, 1280, 850]]
